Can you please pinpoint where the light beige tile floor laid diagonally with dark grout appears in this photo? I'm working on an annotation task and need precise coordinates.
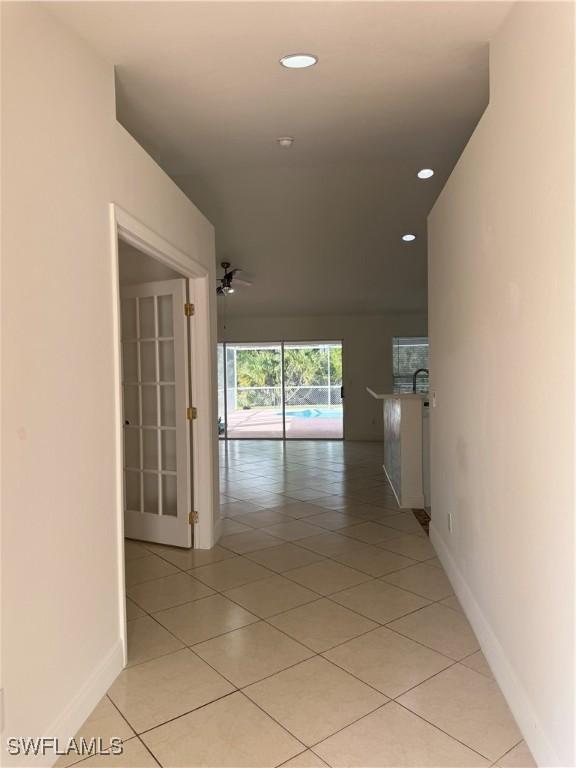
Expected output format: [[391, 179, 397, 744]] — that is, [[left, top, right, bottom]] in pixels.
[[59, 441, 535, 768]]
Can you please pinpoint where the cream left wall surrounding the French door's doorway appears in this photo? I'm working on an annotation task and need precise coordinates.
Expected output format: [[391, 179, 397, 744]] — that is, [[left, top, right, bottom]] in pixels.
[[2, 3, 216, 764]]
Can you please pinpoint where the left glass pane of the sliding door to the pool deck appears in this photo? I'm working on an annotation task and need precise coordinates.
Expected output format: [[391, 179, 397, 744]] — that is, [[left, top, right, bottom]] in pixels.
[[226, 344, 283, 438]]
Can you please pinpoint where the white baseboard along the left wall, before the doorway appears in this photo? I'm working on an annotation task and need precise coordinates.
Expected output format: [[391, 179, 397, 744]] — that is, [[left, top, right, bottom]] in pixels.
[[13, 638, 124, 768]]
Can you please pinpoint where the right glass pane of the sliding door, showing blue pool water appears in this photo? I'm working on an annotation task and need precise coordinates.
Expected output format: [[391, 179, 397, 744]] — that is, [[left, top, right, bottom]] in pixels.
[[284, 342, 343, 439]]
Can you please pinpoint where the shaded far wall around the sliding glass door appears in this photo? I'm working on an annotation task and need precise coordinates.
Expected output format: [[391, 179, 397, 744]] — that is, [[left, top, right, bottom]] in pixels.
[[218, 312, 426, 440]]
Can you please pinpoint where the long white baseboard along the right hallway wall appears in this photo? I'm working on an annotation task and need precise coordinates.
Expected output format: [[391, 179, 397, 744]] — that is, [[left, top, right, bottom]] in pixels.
[[430, 519, 566, 768]]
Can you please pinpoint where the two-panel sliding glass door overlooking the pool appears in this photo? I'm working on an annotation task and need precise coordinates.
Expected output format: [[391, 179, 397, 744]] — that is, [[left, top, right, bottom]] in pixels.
[[218, 341, 344, 440]]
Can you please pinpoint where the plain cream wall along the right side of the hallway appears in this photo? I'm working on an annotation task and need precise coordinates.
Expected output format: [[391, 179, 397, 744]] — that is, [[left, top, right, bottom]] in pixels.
[[428, 3, 575, 766]]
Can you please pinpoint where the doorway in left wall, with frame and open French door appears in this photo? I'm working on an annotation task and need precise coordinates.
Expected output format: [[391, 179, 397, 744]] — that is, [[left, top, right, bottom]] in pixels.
[[110, 204, 218, 665]]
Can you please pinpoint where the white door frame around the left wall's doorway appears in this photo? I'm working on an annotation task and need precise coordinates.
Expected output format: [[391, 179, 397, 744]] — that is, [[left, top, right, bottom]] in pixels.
[[110, 203, 218, 665]]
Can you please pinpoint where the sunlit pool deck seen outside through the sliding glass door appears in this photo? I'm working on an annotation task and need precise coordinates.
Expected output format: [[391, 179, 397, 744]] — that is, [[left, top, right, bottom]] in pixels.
[[228, 406, 343, 440]]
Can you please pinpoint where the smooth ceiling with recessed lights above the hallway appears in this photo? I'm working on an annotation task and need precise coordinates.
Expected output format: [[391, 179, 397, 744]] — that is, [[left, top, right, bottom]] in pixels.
[[51, 0, 510, 315]]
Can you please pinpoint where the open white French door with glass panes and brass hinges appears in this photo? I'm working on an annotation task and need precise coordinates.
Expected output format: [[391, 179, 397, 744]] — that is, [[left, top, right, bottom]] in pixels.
[[120, 280, 192, 547]]
